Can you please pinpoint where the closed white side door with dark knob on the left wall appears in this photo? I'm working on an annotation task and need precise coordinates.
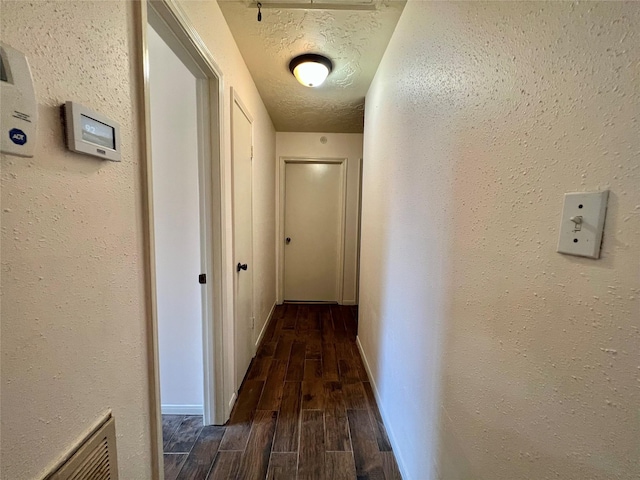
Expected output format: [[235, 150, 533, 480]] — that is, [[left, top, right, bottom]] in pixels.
[[231, 94, 253, 389]]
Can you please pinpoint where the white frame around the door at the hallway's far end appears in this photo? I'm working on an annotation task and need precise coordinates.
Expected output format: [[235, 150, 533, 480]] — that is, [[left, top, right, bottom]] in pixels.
[[276, 156, 348, 304]]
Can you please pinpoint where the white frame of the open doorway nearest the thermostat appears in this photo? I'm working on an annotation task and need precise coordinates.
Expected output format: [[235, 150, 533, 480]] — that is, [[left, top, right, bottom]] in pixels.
[[135, 0, 233, 478]]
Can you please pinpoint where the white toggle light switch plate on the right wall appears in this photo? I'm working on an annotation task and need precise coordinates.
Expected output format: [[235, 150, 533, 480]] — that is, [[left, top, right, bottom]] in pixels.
[[558, 190, 609, 258]]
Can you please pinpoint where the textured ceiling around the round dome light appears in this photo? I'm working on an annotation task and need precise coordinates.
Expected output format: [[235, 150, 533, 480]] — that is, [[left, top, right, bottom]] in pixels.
[[218, 0, 405, 133]]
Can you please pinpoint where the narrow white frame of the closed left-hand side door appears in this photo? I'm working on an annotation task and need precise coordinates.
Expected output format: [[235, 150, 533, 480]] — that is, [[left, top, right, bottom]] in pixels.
[[230, 87, 256, 394]]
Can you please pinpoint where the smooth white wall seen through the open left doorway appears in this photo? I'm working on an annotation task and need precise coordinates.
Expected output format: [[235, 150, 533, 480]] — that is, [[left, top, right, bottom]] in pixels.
[[147, 26, 204, 414]]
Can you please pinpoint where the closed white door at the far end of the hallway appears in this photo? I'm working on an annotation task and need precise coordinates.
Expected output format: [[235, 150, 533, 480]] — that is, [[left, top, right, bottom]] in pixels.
[[284, 161, 345, 302]]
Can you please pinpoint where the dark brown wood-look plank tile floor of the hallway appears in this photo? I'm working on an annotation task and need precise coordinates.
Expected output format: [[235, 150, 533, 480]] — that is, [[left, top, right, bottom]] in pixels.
[[162, 304, 401, 480]]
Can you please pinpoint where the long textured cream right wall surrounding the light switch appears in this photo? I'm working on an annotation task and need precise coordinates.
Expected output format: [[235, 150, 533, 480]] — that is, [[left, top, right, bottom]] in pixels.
[[359, 2, 640, 480]]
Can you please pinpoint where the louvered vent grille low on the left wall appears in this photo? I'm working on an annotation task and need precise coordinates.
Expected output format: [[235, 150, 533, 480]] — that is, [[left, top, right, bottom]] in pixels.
[[45, 417, 118, 480]]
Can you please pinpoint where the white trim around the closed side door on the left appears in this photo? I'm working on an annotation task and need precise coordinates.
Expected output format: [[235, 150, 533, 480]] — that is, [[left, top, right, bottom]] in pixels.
[[230, 87, 256, 392]]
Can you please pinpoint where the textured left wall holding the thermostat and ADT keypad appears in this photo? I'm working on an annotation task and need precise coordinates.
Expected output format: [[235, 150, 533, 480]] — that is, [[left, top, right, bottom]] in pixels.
[[0, 1, 151, 480]]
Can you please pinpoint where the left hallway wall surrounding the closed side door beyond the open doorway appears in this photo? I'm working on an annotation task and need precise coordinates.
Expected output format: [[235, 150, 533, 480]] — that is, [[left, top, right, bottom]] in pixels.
[[179, 0, 276, 398]]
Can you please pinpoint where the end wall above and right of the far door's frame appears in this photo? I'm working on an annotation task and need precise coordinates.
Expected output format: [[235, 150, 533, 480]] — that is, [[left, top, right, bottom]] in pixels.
[[276, 132, 363, 305]]
